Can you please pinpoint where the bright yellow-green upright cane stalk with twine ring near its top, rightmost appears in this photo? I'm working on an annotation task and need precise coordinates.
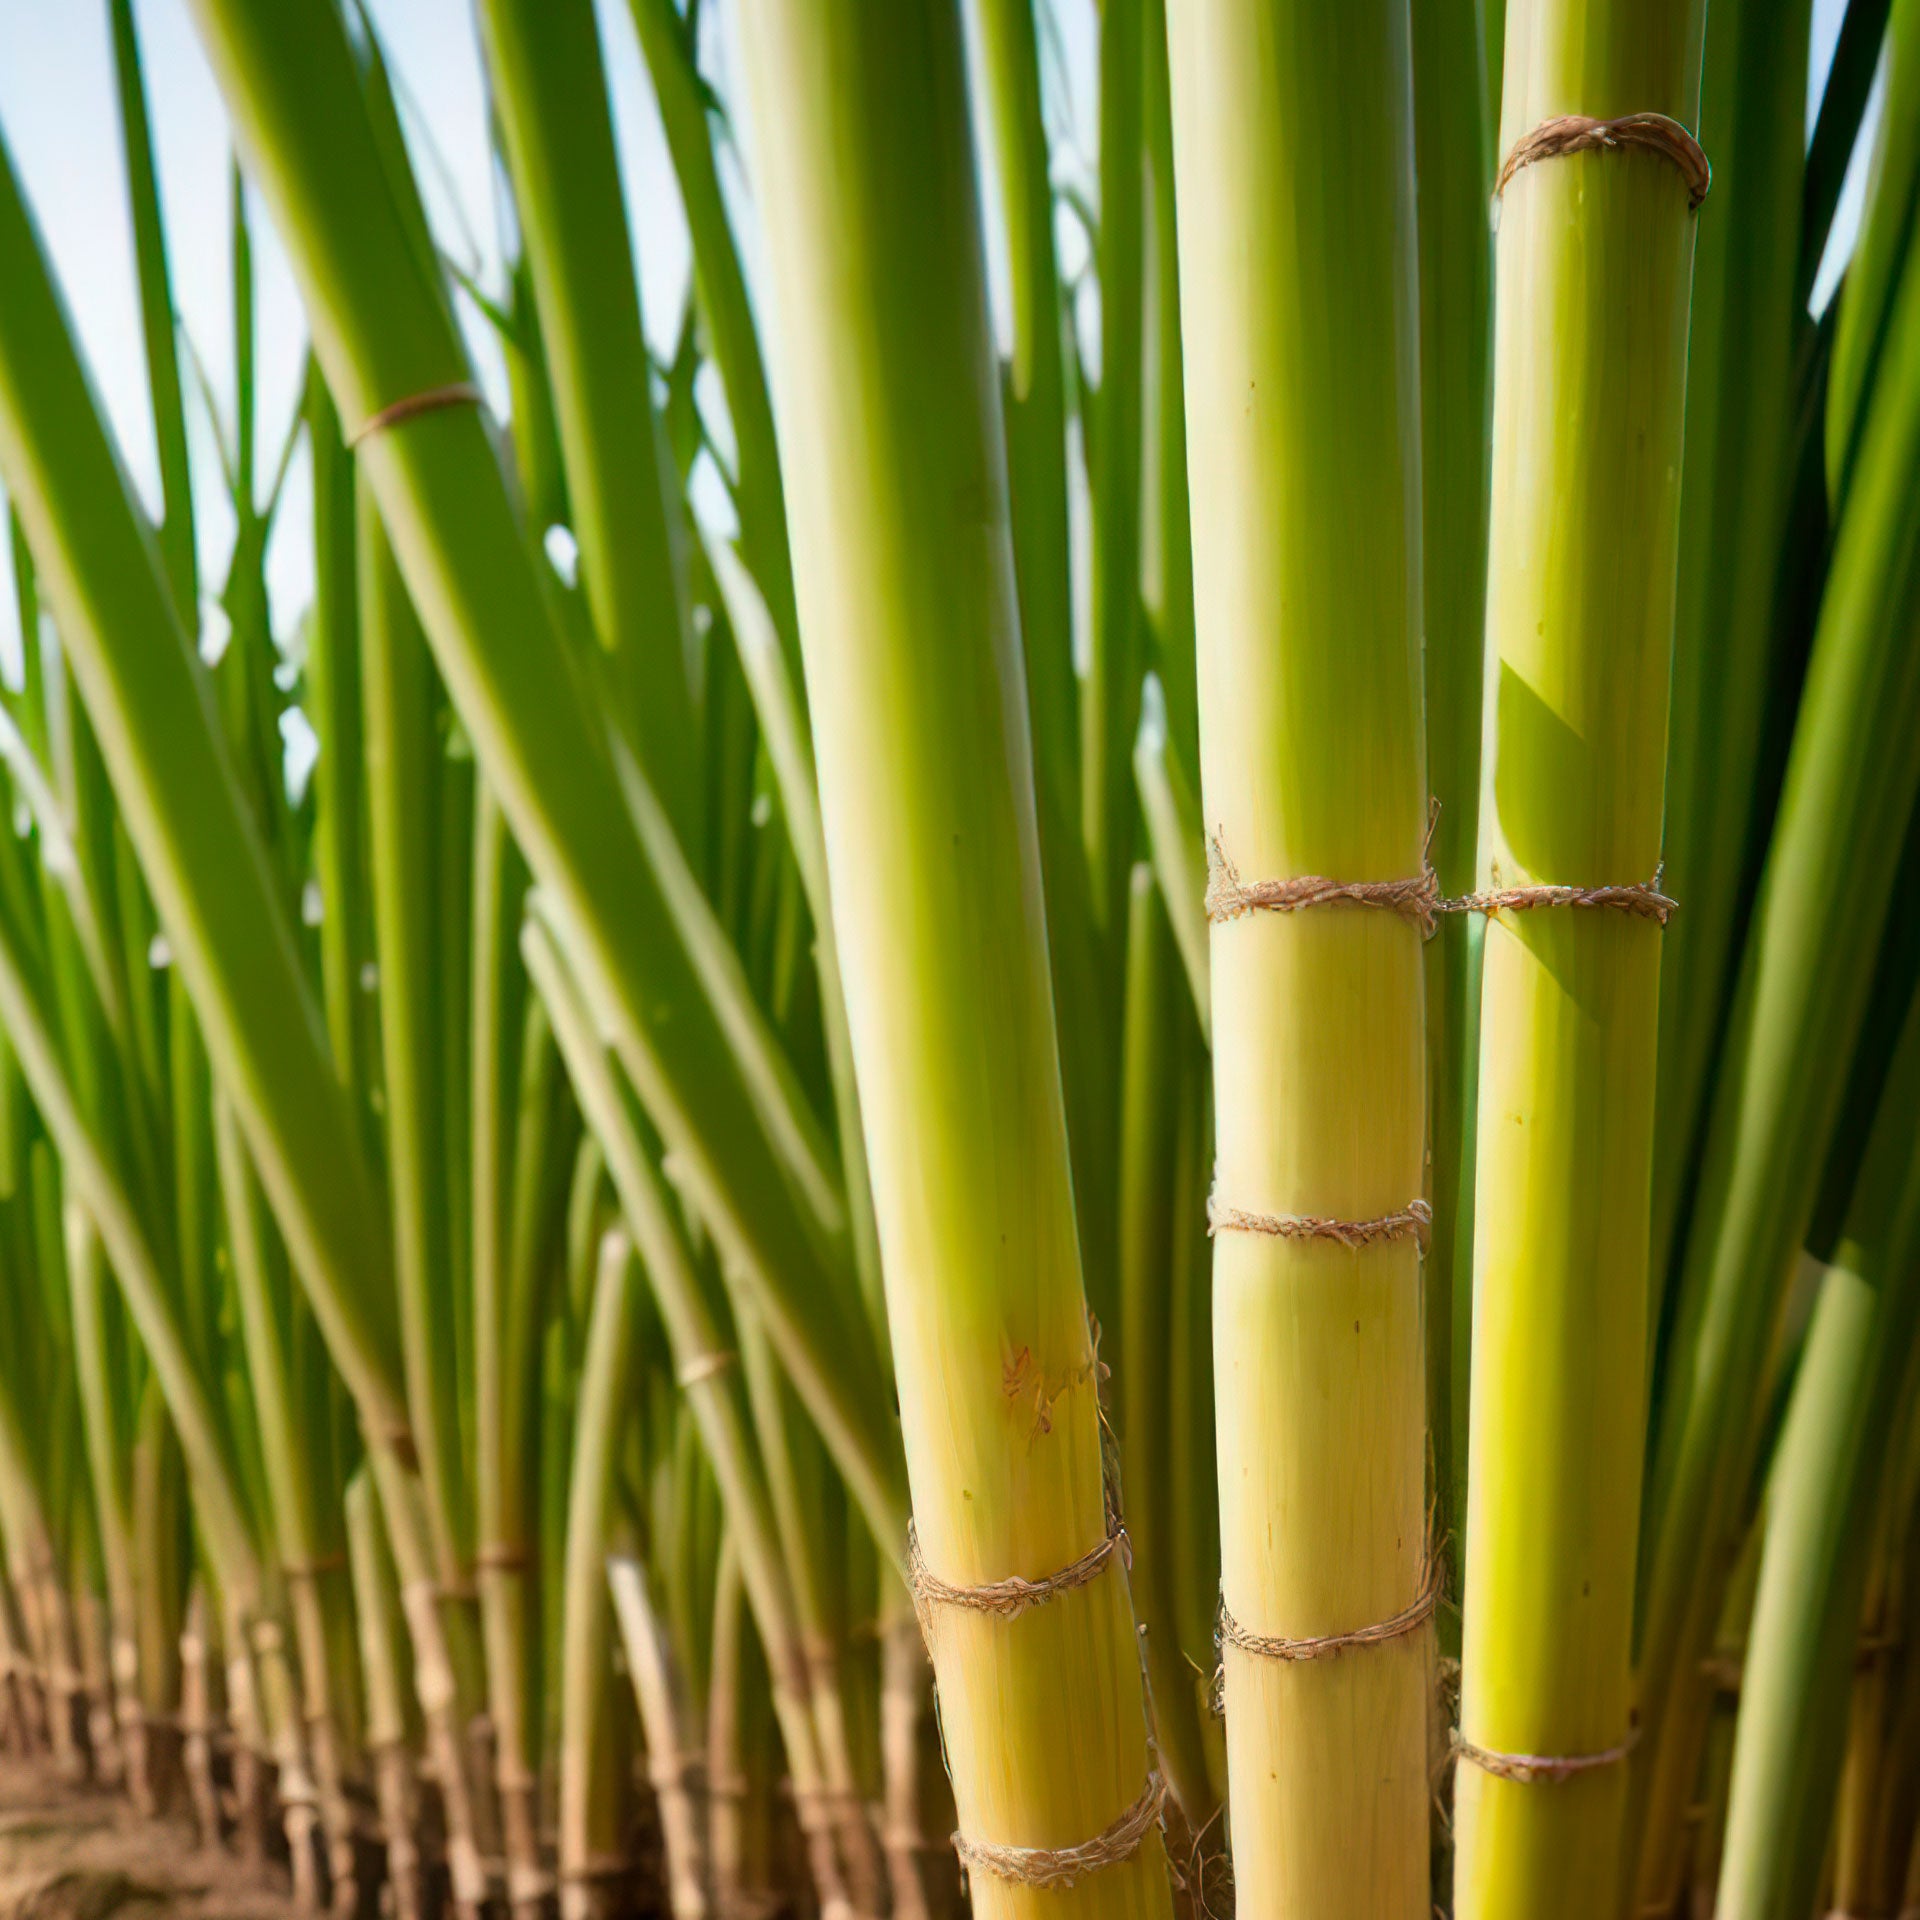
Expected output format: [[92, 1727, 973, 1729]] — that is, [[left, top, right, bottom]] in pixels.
[[1453, 0, 1705, 1920]]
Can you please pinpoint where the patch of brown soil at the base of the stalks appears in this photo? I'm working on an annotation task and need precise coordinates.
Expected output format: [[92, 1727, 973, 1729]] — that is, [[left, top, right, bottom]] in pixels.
[[0, 1755, 296, 1920]]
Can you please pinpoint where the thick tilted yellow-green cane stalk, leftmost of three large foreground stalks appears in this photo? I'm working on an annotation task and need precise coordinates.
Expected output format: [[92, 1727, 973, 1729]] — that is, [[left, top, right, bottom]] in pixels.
[[729, 0, 1167, 1914]]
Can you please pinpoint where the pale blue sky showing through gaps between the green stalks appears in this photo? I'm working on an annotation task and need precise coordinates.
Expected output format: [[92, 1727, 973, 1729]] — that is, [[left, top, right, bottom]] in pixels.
[[0, 0, 1860, 687]]
